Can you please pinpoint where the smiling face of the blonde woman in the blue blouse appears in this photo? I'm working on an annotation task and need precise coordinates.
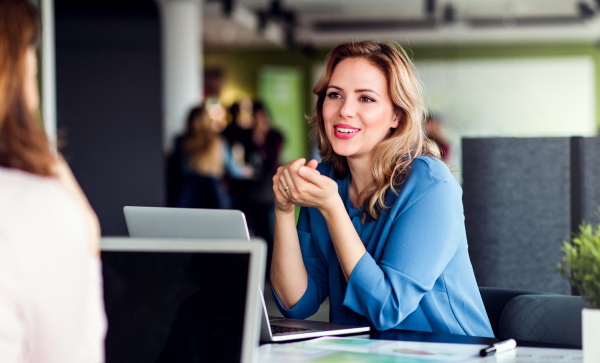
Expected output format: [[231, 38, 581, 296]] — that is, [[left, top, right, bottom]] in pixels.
[[323, 58, 398, 162]]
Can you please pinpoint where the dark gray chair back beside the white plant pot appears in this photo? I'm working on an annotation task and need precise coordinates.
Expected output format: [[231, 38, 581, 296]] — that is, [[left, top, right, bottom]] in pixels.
[[497, 295, 585, 348]]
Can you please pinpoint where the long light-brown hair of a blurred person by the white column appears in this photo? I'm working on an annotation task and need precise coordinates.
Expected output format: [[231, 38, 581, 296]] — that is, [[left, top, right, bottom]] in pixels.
[[185, 106, 225, 178]]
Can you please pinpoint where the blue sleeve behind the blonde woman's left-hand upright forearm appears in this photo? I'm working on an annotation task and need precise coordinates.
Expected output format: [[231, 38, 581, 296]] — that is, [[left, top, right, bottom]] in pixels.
[[273, 207, 329, 319]]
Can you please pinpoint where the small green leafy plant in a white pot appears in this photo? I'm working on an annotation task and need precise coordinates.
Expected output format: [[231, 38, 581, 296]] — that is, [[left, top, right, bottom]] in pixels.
[[558, 219, 600, 363]]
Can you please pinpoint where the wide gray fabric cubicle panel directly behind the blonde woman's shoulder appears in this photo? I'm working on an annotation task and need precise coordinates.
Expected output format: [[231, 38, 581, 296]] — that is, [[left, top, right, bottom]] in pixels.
[[462, 138, 571, 294]]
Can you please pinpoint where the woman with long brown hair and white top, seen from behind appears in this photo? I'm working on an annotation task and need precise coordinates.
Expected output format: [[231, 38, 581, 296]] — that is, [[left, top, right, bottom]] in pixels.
[[0, 0, 106, 363]]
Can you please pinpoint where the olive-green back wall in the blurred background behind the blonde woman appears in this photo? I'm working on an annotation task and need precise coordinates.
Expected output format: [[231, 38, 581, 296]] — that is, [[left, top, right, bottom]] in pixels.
[[204, 43, 600, 158]]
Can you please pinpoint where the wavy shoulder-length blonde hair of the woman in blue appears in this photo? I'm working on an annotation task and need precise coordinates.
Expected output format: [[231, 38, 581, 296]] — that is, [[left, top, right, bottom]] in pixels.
[[308, 41, 440, 219]]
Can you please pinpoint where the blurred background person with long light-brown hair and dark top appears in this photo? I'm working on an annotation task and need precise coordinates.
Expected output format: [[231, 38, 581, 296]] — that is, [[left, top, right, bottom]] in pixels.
[[168, 105, 253, 208]]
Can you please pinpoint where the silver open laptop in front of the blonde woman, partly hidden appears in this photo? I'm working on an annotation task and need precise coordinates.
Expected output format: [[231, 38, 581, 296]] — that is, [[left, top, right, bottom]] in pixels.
[[123, 207, 371, 342]]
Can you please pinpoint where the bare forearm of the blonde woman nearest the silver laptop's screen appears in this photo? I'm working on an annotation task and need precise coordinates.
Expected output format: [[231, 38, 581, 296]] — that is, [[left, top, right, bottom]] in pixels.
[[271, 210, 308, 309]]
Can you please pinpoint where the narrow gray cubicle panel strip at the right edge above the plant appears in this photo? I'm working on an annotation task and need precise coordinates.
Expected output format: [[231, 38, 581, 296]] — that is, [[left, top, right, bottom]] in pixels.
[[580, 137, 600, 224]]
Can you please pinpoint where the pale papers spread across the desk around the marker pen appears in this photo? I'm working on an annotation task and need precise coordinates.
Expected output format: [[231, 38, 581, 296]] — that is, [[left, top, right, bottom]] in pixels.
[[259, 337, 582, 363]]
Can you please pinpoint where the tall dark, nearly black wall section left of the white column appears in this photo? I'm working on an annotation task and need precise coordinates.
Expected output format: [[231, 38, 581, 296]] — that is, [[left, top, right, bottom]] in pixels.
[[53, 0, 166, 236]]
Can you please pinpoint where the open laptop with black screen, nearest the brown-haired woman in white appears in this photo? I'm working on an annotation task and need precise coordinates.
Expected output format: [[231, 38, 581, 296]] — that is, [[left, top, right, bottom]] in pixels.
[[101, 238, 266, 363]]
